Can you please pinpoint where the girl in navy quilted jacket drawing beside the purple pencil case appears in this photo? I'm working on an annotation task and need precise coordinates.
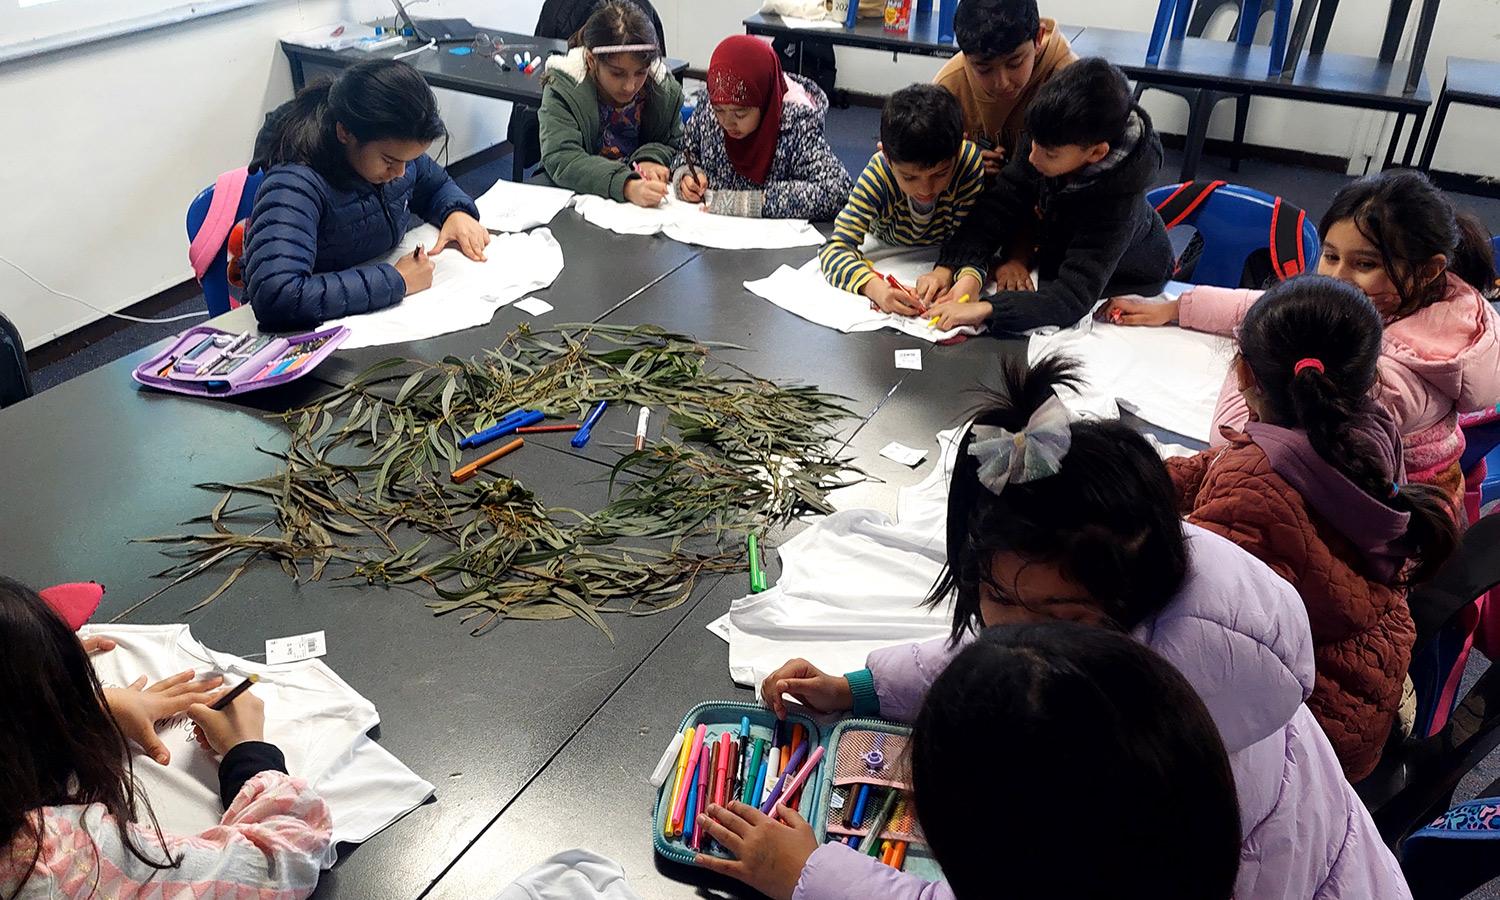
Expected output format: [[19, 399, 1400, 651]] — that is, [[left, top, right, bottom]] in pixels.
[[243, 60, 489, 332]]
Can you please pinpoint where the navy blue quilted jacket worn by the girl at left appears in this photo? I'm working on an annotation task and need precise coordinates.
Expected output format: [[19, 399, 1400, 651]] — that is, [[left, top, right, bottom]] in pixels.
[[243, 155, 479, 332]]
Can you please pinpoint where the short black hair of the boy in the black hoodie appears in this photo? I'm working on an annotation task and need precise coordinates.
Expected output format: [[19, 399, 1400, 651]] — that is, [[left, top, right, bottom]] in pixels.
[[1026, 57, 1136, 147]]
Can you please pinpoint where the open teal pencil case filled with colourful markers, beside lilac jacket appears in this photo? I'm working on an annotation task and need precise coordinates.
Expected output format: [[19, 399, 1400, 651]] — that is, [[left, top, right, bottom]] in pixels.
[[651, 701, 942, 881]]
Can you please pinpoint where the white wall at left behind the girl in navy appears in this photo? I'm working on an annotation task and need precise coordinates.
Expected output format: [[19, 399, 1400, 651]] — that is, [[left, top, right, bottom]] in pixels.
[[0, 0, 542, 347]]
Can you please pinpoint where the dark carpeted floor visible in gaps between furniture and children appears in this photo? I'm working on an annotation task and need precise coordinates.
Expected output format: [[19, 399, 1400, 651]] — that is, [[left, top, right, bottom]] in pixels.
[[23, 107, 1500, 900]]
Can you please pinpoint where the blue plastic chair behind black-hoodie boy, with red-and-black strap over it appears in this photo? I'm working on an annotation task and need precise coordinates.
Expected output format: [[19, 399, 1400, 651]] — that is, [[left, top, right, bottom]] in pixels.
[[1146, 185, 1319, 288]]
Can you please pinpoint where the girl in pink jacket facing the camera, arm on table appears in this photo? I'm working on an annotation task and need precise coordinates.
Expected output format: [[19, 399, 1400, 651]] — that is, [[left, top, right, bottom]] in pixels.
[[1109, 171, 1500, 510]]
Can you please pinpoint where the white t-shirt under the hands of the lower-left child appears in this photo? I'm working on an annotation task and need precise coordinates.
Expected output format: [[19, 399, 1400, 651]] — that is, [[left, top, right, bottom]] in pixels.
[[78, 624, 434, 869]]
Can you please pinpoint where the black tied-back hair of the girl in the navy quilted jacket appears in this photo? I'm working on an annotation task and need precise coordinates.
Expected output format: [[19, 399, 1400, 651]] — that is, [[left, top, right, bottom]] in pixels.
[[254, 60, 447, 186]]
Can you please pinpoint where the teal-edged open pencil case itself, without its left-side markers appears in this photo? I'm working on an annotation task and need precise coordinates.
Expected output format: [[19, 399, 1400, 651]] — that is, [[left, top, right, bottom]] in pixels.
[[653, 701, 942, 881]]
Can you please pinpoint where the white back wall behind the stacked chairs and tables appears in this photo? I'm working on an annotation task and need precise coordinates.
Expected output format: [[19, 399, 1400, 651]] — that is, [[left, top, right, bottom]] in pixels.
[[653, 0, 1500, 177]]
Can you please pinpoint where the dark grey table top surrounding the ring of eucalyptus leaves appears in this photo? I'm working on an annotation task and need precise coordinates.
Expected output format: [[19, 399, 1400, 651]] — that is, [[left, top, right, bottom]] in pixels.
[[0, 186, 1194, 900]]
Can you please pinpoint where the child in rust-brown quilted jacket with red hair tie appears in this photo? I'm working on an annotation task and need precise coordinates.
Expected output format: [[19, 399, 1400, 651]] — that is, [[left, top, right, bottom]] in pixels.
[[1167, 275, 1457, 782]]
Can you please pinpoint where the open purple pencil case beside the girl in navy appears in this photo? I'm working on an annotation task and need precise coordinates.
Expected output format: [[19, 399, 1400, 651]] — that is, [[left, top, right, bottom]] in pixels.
[[131, 326, 350, 396]]
